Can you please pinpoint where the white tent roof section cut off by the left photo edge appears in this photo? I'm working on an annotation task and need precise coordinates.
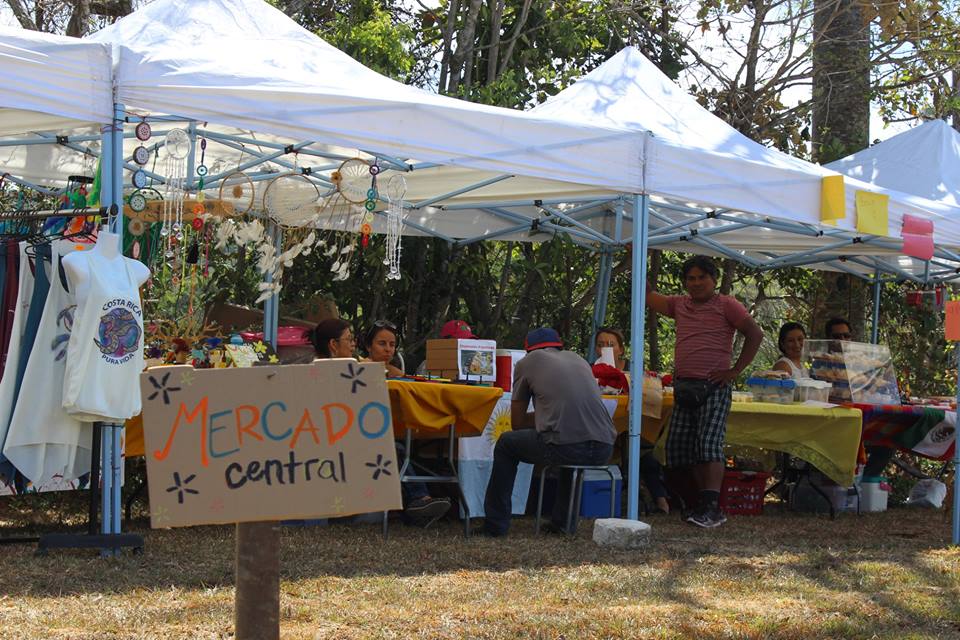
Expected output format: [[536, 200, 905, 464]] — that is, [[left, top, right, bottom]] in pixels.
[[0, 27, 113, 135]]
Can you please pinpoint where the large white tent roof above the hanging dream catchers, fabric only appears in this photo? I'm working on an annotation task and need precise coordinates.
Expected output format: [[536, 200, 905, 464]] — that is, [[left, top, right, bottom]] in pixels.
[[90, 0, 642, 192]]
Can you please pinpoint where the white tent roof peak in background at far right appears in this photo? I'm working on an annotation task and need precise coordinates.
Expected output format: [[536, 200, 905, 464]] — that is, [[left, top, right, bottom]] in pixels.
[[827, 120, 960, 209]]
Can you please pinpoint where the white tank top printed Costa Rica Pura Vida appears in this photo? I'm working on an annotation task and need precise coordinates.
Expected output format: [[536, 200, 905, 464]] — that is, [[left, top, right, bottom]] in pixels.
[[63, 249, 143, 422]]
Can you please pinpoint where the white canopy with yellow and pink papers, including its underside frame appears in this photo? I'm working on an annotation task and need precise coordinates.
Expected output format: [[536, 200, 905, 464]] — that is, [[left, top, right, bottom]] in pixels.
[[532, 48, 960, 280]]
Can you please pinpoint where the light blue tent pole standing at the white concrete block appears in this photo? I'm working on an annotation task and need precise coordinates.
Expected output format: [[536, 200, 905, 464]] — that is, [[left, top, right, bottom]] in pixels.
[[627, 194, 650, 520]]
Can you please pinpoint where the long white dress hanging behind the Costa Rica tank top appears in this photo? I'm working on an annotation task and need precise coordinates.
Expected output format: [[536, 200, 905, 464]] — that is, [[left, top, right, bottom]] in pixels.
[[3, 241, 93, 486]]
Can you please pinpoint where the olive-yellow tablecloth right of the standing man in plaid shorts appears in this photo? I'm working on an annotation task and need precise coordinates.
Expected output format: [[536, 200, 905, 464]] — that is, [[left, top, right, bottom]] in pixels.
[[648, 400, 863, 487]]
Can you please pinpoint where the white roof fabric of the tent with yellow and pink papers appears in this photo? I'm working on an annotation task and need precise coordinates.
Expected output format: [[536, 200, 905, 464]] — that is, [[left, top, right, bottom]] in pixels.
[[532, 47, 960, 247]]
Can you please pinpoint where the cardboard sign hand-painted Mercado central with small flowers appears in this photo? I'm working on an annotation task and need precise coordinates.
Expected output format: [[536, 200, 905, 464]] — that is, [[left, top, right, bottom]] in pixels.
[[140, 359, 401, 527]]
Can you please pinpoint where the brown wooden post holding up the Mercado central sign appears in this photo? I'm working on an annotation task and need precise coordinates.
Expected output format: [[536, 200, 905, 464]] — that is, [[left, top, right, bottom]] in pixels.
[[234, 522, 280, 640]]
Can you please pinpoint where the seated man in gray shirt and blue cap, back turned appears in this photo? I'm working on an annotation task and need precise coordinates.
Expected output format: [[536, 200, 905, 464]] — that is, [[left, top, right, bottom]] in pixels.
[[479, 328, 616, 537]]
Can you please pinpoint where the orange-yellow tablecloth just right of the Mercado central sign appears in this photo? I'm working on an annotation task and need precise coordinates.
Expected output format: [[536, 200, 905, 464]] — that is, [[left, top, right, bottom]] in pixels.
[[387, 380, 503, 437]]
